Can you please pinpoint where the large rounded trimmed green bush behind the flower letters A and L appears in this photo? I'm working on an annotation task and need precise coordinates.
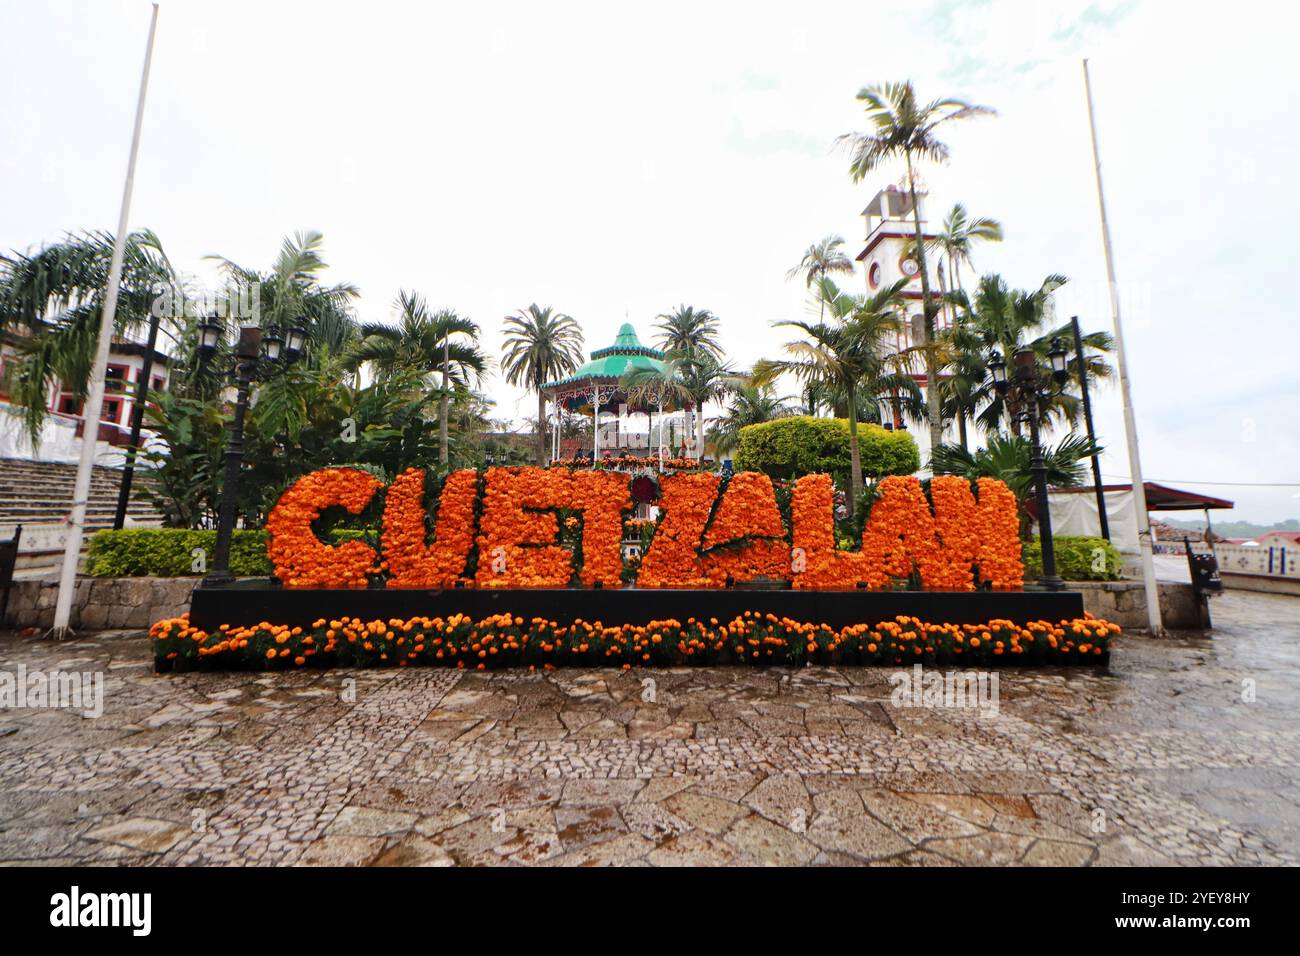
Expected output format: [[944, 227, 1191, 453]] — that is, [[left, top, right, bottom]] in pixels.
[[736, 416, 920, 483]]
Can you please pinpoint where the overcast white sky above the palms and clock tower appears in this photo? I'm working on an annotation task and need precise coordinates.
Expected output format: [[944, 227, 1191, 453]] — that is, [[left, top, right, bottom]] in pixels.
[[0, 0, 1300, 522]]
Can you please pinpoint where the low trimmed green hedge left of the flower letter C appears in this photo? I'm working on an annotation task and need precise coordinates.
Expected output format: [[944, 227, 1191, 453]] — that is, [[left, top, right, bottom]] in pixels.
[[86, 528, 274, 578]]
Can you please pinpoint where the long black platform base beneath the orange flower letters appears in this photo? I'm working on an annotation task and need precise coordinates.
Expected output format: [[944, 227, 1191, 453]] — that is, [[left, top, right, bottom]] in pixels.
[[190, 584, 1083, 631]]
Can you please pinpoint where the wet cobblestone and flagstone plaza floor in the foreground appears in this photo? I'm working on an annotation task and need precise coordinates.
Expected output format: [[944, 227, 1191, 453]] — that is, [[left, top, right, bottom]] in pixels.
[[0, 592, 1300, 866]]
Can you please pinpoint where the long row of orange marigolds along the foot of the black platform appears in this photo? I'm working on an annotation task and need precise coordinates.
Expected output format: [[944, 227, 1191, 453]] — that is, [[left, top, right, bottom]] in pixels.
[[150, 611, 1119, 671]]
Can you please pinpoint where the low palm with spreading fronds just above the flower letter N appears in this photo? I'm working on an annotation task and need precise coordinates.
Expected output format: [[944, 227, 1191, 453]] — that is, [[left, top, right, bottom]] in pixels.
[[930, 432, 1101, 537]]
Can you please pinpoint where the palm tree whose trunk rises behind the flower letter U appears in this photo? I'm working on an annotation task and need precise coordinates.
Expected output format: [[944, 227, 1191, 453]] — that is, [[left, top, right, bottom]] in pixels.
[[347, 290, 488, 464]]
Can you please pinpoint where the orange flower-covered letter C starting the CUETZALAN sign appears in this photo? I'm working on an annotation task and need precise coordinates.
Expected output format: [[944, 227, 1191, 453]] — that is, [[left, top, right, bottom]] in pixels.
[[267, 468, 382, 588]]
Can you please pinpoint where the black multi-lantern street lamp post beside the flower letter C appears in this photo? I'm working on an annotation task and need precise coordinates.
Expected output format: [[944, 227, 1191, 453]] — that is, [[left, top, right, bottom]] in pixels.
[[199, 321, 306, 588]]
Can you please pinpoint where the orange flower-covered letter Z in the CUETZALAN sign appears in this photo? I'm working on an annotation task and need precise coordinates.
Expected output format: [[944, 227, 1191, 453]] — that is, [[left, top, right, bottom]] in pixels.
[[637, 473, 719, 588]]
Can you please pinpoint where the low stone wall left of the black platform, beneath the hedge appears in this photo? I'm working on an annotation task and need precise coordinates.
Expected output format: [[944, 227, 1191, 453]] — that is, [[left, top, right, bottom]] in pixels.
[[7, 576, 200, 631]]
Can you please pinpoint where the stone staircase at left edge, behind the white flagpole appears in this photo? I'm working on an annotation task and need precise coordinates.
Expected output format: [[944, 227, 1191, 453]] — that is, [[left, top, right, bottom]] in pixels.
[[0, 458, 163, 578]]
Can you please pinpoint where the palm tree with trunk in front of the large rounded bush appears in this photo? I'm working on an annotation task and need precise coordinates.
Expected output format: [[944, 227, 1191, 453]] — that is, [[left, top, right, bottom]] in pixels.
[[754, 278, 917, 514]]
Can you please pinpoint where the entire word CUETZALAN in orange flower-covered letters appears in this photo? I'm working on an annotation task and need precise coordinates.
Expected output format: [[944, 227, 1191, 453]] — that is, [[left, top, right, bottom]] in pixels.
[[267, 467, 1023, 591]]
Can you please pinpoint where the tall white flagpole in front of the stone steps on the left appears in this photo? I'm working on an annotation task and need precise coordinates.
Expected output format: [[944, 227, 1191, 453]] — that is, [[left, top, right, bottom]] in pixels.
[[51, 4, 159, 639]]
